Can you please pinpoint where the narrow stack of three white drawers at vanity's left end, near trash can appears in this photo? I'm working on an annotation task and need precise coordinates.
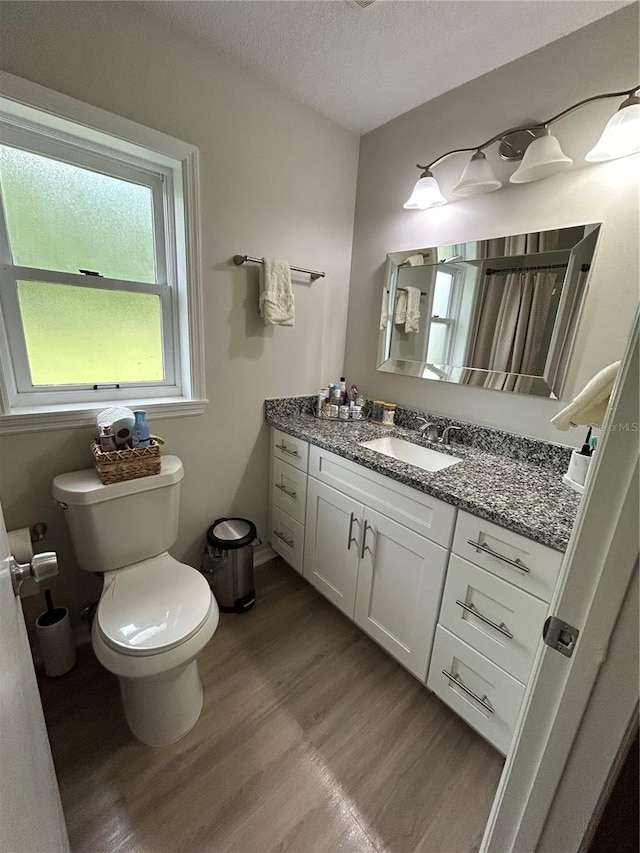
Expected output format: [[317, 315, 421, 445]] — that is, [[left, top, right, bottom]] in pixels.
[[269, 428, 309, 573]]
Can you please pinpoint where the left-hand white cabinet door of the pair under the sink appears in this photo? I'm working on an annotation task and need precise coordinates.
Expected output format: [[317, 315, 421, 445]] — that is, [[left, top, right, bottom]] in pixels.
[[304, 477, 363, 619]]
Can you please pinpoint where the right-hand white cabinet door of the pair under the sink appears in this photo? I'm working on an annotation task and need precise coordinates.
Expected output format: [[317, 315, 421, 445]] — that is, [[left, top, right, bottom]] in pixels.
[[355, 509, 447, 681]]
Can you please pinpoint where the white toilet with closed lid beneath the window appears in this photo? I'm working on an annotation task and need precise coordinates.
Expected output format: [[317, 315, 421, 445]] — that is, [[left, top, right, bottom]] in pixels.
[[53, 456, 219, 746]]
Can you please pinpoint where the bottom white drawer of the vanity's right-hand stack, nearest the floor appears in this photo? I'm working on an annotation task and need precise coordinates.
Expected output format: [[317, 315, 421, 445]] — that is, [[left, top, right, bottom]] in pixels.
[[427, 625, 525, 754]]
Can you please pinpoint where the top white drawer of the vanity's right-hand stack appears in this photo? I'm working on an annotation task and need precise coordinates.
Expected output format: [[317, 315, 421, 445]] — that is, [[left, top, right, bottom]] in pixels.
[[453, 512, 563, 601]]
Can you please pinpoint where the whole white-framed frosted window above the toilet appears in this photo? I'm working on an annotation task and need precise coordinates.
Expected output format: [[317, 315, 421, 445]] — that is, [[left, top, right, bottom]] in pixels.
[[0, 74, 206, 431]]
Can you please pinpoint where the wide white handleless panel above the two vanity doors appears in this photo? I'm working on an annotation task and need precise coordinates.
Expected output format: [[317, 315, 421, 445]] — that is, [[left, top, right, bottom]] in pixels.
[[309, 445, 456, 548]]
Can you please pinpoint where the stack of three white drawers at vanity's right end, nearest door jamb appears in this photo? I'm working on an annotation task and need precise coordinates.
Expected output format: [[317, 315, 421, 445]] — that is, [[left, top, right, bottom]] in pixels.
[[427, 512, 563, 753]]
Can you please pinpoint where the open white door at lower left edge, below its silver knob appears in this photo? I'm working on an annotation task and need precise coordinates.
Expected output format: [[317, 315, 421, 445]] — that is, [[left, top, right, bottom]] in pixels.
[[0, 500, 69, 853]]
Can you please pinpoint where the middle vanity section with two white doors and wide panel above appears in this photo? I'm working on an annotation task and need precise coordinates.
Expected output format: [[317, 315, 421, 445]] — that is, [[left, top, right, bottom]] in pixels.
[[304, 446, 455, 681]]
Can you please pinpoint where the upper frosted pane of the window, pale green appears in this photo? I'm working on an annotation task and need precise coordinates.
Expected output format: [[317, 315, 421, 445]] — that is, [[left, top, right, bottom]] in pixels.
[[0, 145, 156, 282]]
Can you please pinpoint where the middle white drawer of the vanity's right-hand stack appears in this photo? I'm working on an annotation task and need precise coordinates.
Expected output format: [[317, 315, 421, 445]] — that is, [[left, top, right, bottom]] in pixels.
[[439, 554, 548, 684]]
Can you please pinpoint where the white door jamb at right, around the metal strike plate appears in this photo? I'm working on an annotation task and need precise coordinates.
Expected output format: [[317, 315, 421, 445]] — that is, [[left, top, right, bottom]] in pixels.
[[480, 315, 640, 853]]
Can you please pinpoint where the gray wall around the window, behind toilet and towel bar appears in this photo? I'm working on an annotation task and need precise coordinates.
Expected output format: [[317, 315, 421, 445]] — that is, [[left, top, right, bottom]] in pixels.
[[0, 2, 358, 632]]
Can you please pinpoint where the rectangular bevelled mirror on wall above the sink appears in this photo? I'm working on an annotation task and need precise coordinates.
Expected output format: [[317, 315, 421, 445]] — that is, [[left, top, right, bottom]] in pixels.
[[378, 223, 600, 399]]
